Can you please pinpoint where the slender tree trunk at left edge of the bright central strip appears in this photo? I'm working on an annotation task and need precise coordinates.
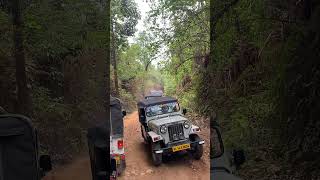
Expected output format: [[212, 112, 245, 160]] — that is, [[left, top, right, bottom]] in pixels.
[[111, 20, 119, 97]]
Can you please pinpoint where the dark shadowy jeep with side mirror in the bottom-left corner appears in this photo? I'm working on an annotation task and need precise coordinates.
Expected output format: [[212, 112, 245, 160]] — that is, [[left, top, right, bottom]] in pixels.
[[0, 113, 51, 180]]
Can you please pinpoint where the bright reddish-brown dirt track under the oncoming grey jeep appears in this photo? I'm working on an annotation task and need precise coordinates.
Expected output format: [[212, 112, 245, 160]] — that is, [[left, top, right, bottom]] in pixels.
[[119, 112, 210, 180]]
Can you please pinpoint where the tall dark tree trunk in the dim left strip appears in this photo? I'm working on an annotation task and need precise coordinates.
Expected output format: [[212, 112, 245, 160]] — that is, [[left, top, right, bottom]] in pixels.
[[12, 0, 32, 115]]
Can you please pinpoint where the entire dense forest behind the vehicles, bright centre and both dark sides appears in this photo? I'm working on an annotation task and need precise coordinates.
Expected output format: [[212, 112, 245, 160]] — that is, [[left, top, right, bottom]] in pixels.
[[0, 0, 320, 180]]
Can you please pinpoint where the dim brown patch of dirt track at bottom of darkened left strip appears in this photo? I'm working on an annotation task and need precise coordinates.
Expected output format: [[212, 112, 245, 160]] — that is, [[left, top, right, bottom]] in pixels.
[[43, 155, 92, 180]]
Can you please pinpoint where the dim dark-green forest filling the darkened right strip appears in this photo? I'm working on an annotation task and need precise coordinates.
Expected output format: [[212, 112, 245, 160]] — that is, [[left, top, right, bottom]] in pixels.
[[205, 0, 320, 179]]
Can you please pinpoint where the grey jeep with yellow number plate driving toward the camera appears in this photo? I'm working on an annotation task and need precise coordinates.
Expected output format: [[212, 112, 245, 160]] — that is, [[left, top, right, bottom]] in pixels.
[[138, 96, 204, 166]]
